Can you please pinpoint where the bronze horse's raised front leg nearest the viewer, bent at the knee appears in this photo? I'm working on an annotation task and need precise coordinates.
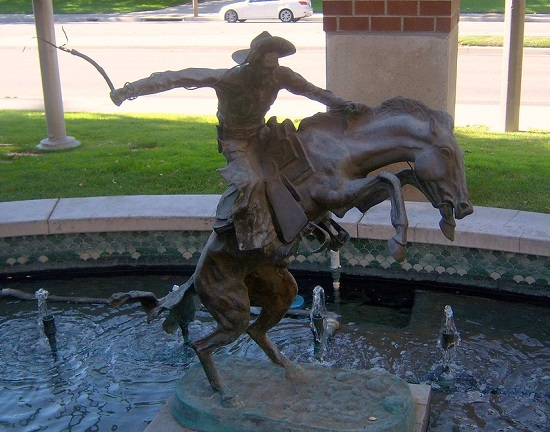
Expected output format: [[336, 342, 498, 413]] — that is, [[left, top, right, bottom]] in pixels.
[[314, 171, 409, 261]]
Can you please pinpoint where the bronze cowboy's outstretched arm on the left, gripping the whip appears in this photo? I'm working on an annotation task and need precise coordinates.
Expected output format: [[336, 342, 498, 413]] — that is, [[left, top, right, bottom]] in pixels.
[[110, 68, 225, 106]]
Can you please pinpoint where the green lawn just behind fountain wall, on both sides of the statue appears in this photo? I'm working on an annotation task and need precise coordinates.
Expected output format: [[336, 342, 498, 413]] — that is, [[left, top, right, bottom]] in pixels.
[[0, 111, 550, 213]]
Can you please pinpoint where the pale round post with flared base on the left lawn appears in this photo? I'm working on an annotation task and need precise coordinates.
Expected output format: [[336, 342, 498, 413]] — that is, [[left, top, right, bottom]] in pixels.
[[32, 0, 80, 150]]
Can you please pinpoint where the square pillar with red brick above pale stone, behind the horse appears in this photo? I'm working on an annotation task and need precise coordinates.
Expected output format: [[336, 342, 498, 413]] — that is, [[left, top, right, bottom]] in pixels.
[[323, 0, 460, 200]]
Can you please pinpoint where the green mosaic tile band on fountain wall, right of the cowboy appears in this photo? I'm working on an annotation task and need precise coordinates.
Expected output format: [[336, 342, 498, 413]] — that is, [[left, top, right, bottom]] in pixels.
[[291, 239, 550, 297]]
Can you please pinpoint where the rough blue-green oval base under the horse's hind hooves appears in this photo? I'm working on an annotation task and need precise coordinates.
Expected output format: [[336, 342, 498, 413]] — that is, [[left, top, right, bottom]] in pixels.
[[167, 356, 416, 432]]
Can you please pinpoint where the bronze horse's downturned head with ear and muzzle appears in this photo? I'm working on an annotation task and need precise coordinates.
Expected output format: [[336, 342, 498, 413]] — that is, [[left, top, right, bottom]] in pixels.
[[414, 119, 474, 240]]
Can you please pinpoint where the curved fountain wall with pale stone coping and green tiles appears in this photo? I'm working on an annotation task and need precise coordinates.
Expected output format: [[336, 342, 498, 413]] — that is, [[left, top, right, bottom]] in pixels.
[[0, 196, 550, 297]]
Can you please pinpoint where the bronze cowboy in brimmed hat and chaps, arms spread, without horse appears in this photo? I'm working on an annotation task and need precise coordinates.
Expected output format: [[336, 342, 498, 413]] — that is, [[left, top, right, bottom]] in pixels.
[[111, 32, 355, 250]]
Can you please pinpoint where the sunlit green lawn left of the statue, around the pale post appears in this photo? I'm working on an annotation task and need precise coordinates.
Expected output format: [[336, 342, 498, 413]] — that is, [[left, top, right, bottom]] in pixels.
[[0, 111, 225, 201]]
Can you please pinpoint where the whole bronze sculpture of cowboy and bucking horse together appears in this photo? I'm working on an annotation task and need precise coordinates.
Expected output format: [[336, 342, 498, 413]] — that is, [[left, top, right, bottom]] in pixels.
[[111, 33, 473, 407]]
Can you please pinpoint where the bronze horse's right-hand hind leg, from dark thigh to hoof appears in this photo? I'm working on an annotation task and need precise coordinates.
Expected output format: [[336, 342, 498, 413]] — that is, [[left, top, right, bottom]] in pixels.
[[245, 266, 307, 381]]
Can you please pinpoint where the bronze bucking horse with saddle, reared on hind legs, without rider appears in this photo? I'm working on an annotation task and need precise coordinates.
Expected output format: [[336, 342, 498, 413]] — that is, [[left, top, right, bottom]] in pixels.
[[111, 97, 473, 407]]
